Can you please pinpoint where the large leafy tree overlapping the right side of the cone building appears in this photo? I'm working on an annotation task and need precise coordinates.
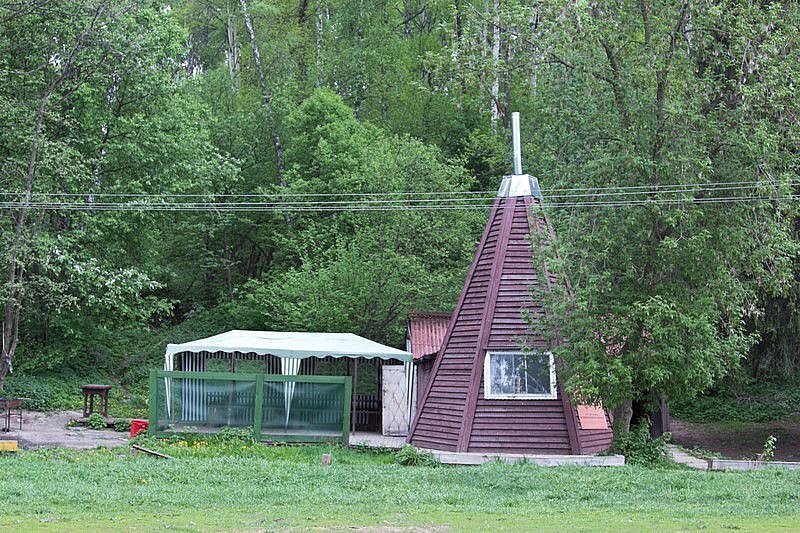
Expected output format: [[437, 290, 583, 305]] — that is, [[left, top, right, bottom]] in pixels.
[[516, 2, 800, 431]]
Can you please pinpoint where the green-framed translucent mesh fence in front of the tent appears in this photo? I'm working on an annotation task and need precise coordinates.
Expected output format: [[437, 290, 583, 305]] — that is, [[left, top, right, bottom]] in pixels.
[[150, 370, 352, 443]]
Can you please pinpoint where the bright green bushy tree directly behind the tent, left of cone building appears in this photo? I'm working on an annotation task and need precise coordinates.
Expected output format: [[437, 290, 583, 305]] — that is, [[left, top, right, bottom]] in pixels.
[[242, 90, 485, 344]]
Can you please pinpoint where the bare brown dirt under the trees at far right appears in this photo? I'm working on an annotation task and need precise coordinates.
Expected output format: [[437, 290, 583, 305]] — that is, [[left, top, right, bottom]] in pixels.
[[670, 415, 800, 461]]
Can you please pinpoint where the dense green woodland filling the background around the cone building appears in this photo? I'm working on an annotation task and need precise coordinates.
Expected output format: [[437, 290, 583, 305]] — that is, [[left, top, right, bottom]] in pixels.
[[0, 0, 800, 426]]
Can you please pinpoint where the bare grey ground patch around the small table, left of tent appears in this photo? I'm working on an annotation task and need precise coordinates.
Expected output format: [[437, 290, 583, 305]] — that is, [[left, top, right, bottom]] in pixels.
[[0, 411, 128, 450]]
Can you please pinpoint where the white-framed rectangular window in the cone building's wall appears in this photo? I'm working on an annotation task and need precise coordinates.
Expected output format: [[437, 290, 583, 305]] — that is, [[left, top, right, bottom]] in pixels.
[[483, 351, 557, 400]]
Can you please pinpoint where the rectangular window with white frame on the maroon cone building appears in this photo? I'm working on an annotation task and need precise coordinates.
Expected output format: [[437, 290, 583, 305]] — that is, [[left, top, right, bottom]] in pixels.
[[484, 352, 554, 396]]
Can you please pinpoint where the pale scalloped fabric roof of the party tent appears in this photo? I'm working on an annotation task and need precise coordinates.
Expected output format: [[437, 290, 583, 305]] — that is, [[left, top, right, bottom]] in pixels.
[[165, 330, 412, 362]]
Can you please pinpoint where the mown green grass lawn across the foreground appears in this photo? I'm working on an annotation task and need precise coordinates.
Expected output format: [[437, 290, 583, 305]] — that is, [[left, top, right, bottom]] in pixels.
[[0, 442, 800, 531]]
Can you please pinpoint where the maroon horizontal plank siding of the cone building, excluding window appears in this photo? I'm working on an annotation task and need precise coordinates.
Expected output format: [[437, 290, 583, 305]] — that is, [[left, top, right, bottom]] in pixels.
[[409, 193, 610, 454]]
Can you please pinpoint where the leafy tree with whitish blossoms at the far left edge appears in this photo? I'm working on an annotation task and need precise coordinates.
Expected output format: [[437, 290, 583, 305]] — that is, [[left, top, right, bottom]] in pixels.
[[0, 1, 235, 385]]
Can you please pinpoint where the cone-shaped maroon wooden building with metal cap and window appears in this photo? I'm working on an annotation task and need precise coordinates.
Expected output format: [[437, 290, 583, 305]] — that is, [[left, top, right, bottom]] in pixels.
[[408, 117, 612, 454]]
